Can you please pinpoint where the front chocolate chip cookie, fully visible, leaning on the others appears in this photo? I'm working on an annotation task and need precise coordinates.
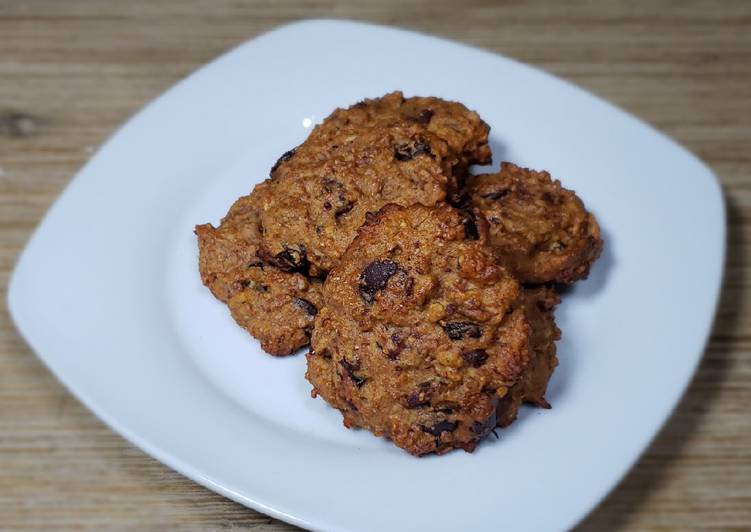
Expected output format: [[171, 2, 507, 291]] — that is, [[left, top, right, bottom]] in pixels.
[[306, 205, 534, 455]]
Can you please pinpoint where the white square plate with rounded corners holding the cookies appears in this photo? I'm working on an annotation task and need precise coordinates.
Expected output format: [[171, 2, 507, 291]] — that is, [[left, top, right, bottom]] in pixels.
[[4, 21, 725, 530]]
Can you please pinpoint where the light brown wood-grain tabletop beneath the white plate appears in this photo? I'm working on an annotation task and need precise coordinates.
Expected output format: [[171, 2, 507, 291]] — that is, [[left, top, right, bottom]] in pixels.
[[0, 0, 751, 530]]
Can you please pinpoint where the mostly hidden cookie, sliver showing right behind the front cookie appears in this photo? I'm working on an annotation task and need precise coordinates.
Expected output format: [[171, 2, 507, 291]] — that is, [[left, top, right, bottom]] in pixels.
[[497, 286, 561, 427]]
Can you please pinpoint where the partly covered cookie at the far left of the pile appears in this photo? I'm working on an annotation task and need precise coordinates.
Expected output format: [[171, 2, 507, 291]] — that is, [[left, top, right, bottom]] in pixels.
[[195, 188, 321, 355]]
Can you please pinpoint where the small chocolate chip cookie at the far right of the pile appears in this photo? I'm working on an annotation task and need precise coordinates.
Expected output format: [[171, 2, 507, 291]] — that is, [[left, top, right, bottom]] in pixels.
[[466, 163, 602, 284]]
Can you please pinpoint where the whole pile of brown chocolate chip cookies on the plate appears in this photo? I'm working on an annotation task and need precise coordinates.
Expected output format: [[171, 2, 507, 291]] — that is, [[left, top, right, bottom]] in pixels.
[[196, 92, 602, 455]]
